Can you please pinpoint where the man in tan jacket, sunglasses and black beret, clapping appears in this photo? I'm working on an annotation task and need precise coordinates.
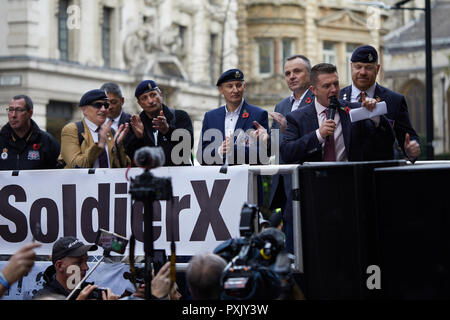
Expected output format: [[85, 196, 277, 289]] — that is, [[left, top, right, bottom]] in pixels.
[[60, 89, 131, 168]]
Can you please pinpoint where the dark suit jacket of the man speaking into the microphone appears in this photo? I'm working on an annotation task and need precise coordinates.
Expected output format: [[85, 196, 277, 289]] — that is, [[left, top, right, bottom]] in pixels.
[[281, 101, 394, 163]]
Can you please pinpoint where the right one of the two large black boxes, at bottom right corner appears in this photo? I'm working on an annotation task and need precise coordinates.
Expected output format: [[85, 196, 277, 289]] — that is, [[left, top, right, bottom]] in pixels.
[[375, 164, 450, 299]]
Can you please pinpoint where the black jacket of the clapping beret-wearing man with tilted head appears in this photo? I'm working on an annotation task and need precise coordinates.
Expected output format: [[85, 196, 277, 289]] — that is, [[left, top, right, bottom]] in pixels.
[[124, 104, 194, 166]]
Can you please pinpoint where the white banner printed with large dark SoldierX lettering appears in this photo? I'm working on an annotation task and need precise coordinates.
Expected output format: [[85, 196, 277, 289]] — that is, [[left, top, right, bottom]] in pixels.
[[0, 166, 248, 255]]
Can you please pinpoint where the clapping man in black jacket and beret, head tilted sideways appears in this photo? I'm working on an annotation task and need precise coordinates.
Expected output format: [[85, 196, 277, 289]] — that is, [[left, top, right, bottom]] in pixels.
[[125, 80, 194, 166]]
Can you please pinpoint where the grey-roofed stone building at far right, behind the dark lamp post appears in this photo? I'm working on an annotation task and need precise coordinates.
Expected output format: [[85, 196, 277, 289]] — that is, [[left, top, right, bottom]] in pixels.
[[384, 0, 450, 158]]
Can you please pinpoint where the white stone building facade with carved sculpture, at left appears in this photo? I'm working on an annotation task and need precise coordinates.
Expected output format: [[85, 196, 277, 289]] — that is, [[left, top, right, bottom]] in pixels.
[[0, 0, 238, 152]]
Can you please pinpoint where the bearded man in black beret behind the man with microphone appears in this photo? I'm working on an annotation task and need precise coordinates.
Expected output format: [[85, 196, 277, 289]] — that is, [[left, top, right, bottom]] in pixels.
[[340, 45, 420, 162]]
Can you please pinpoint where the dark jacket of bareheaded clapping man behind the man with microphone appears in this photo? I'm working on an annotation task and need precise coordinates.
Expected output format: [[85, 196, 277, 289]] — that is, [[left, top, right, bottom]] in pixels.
[[270, 89, 314, 209]]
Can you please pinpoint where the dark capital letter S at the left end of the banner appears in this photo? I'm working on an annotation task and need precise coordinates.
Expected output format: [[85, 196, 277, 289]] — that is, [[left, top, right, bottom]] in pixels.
[[0, 185, 28, 242]]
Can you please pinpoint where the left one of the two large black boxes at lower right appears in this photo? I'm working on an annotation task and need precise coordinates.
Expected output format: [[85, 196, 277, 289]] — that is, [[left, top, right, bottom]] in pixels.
[[294, 161, 406, 300]]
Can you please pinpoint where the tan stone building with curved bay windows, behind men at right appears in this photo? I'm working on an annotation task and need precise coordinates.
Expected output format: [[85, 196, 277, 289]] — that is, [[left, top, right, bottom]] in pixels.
[[238, 0, 388, 111]]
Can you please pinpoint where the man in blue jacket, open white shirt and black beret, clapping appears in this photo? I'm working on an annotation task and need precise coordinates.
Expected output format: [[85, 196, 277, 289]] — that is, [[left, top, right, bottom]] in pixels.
[[197, 69, 269, 165]]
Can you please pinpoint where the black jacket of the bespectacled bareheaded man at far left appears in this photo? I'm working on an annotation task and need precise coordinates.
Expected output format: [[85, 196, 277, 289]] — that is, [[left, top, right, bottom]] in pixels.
[[0, 119, 60, 170]]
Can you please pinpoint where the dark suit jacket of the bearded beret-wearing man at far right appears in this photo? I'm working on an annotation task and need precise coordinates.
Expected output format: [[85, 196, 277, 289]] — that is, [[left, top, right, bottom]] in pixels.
[[340, 83, 419, 155]]
